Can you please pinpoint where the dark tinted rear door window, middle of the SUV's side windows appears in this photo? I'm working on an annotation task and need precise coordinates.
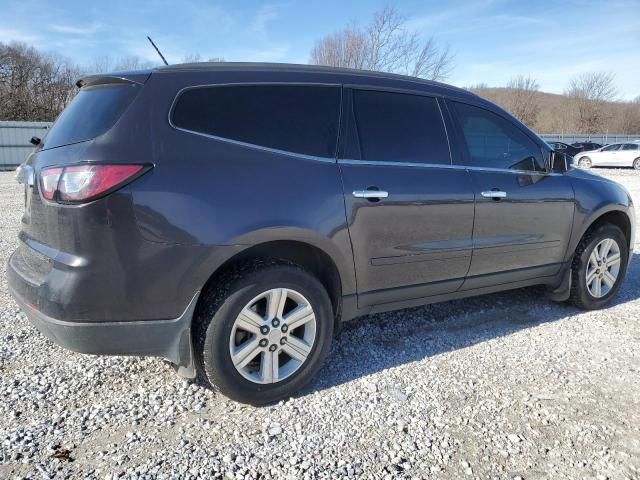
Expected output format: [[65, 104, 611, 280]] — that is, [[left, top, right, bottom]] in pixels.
[[344, 90, 451, 165]]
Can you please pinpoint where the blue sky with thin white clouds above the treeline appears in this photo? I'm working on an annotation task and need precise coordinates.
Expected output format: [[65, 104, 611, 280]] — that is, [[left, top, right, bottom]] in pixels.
[[0, 0, 640, 99]]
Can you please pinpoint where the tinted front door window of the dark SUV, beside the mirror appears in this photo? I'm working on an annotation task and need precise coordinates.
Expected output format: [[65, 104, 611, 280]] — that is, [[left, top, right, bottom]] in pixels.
[[453, 102, 544, 171]]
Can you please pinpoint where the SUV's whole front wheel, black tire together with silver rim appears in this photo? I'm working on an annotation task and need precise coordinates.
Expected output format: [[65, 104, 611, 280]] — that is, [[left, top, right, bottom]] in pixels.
[[569, 224, 629, 310]]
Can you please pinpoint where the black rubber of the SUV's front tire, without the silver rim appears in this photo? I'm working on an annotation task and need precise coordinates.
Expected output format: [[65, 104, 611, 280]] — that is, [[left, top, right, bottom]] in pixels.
[[573, 225, 629, 310]]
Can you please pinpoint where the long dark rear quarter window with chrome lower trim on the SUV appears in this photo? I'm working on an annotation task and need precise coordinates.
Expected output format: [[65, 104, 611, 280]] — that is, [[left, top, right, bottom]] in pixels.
[[172, 85, 340, 157]]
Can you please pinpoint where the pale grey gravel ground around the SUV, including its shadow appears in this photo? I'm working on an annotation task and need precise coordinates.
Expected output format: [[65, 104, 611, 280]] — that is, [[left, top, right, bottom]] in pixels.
[[0, 170, 640, 479]]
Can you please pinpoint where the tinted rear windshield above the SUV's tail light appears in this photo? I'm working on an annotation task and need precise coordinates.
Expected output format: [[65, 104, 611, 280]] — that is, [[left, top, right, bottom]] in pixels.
[[44, 84, 140, 148]]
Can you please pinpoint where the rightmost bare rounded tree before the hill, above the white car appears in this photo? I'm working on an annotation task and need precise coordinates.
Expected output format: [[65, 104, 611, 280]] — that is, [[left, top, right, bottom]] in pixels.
[[566, 72, 617, 133]]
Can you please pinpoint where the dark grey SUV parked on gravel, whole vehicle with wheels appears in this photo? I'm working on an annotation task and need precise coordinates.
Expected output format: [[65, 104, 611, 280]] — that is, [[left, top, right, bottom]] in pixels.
[[8, 63, 634, 404]]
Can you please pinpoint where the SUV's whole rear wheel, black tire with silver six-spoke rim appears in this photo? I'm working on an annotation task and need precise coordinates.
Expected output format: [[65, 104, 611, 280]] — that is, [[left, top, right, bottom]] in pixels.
[[194, 261, 334, 405]]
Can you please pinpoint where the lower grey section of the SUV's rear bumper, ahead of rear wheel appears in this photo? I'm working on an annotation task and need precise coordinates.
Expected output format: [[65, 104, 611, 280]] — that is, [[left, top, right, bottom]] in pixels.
[[7, 266, 199, 378]]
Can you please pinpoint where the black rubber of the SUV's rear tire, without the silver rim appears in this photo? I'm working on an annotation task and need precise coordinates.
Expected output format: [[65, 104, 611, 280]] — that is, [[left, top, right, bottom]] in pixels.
[[198, 265, 334, 405]]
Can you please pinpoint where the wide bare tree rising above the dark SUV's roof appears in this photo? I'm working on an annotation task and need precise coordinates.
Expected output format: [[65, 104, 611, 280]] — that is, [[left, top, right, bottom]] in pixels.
[[310, 7, 453, 80]]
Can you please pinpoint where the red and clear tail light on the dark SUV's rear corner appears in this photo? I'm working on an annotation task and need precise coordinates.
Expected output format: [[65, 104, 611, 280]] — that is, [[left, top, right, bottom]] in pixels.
[[40, 164, 149, 203]]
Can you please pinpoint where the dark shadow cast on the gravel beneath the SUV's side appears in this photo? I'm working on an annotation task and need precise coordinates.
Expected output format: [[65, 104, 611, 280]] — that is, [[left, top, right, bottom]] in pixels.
[[308, 255, 640, 396]]
